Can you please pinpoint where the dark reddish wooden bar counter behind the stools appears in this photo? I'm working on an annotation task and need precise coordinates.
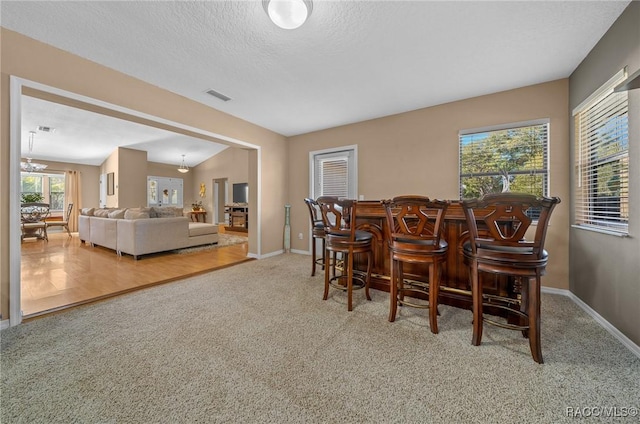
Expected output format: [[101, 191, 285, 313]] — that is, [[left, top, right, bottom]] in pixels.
[[356, 201, 520, 315]]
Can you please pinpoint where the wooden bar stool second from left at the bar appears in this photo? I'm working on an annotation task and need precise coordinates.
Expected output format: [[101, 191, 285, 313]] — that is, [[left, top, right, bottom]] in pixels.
[[316, 197, 373, 311]]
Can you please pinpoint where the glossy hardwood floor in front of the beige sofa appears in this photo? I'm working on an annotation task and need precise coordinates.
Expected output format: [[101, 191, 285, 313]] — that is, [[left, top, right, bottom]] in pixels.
[[21, 228, 252, 319]]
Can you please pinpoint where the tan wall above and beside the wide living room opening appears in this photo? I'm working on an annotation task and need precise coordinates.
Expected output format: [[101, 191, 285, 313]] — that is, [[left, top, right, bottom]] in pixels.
[[0, 28, 288, 319]]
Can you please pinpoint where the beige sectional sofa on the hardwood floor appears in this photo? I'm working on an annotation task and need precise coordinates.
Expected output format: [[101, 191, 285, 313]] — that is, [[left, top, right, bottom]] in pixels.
[[78, 208, 219, 259]]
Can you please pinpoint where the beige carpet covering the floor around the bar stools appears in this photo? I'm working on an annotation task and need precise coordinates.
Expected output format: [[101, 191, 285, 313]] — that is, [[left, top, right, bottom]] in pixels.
[[0, 254, 640, 424]]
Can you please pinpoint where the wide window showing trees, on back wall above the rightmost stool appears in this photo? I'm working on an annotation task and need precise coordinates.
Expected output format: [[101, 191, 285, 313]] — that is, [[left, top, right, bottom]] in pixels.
[[459, 120, 549, 199]]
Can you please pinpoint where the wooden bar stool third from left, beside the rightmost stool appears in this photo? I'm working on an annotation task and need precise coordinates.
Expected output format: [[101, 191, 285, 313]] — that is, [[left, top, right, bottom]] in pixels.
[[383, 196, 449, 334]]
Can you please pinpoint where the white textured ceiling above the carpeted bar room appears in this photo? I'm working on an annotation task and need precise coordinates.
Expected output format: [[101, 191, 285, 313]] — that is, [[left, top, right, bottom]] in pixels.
[[0, 0, 629, 165]]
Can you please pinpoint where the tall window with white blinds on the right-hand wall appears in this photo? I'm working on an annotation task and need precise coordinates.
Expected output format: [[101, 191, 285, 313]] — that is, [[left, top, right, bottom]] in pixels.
[[574, 70, 629, 234]]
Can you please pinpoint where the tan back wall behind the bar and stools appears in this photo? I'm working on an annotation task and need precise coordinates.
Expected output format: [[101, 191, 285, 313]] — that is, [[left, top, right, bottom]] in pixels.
[[288, 79, 570, 289]]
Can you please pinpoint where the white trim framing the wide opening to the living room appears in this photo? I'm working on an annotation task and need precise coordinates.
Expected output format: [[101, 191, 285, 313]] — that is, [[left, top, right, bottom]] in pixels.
[[9, 75, 262, 326]]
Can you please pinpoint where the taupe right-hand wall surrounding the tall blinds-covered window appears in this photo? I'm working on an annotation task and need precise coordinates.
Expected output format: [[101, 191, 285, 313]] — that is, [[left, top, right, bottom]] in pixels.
[[570, 1, 640, 345]]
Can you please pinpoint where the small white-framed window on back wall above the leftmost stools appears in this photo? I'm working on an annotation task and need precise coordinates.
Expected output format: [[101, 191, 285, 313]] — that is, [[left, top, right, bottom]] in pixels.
[[311, 149, 357, 198]]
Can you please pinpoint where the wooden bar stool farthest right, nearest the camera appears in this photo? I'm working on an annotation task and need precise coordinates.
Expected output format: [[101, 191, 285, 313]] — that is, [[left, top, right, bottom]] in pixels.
[[462, 193, 560, 364]]
